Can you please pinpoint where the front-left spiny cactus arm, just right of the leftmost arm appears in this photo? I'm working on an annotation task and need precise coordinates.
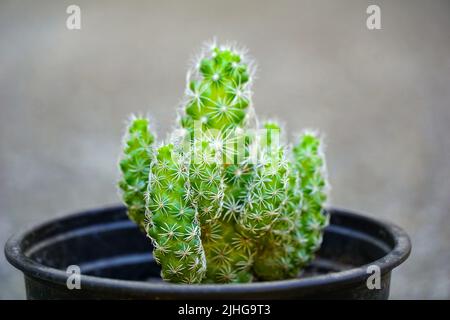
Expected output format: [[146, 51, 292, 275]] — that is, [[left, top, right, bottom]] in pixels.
[[147, 144, 206, 283]]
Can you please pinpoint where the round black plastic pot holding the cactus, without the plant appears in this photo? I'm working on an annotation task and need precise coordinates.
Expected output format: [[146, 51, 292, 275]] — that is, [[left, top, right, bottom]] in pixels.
[[5, 207, 411, 299]]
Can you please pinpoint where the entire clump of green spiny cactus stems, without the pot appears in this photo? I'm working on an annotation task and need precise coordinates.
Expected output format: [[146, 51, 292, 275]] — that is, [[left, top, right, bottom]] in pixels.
[[119, 43, 328, 283]]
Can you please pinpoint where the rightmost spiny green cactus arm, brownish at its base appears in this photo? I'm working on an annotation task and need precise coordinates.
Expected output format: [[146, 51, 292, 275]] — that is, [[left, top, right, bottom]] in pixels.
[[254, 131, 328, 280]]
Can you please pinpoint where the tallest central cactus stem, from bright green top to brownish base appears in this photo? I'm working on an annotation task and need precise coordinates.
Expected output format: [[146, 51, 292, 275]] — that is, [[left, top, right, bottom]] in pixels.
[[181, 44, 253, 282]]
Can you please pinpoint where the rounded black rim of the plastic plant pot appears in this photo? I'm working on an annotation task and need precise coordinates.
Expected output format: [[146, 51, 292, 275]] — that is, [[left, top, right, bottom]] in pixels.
[[5, 206, 411, 294]]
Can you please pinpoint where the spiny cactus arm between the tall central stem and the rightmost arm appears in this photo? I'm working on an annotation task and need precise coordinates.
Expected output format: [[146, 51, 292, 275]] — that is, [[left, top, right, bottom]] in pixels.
[[239, 122, 289, 238]]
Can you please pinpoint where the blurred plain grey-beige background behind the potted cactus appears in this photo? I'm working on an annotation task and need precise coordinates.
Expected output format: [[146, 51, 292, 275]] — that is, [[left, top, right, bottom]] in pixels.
[[0, 0, 450, 299]]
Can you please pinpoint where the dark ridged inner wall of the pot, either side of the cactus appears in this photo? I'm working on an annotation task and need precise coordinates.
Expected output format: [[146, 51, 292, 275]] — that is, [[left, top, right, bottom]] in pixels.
[[17, 207, 395, 281]]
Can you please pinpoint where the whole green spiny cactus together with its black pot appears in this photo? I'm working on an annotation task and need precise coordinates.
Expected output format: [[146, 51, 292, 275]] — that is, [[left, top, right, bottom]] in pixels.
[[5, 43, 410, 299]]
